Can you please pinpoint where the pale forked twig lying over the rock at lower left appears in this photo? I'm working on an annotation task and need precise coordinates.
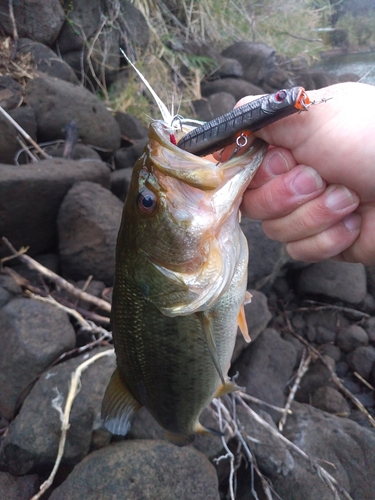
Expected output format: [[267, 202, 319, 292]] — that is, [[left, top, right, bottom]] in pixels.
[[31, 349, 114, 500]]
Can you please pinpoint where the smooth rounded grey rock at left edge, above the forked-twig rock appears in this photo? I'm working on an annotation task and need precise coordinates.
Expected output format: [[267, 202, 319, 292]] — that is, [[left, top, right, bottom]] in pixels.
[[0, 298, 75, 418]]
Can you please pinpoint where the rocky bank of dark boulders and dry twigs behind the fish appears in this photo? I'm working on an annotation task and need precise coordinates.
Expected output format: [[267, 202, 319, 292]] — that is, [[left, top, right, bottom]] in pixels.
[[0, 0, 375, 500]]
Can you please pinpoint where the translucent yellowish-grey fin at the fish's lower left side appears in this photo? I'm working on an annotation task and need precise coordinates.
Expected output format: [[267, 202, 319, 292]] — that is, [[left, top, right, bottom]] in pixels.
[[102, 368, 142, 436]]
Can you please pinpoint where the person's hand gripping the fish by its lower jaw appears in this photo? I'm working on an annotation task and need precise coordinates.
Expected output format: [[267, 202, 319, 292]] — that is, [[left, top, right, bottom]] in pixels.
[[237, 83, 375, 264]]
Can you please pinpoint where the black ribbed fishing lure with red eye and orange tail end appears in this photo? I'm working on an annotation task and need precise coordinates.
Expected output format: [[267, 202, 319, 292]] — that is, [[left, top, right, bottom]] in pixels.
[[177, 87, 313, 156]]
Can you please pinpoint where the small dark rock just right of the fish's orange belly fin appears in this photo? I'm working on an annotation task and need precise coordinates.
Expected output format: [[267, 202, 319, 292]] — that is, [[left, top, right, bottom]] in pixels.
[[232, 290, 272, 363]]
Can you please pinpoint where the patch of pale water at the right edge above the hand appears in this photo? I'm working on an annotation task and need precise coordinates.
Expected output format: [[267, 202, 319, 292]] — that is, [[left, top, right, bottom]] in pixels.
[[315, 52, 375, 85]]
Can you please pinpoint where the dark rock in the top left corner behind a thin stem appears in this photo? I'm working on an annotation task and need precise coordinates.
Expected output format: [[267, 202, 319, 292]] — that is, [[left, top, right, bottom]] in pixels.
[[0, 0, 65, 45]]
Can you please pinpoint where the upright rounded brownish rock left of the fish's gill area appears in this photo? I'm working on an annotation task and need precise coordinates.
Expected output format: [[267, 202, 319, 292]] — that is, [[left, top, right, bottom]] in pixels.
[[57, 182, 122, 285]]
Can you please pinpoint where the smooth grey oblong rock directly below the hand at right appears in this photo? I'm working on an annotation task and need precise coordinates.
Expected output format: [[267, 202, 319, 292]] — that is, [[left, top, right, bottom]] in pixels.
[[297, 260, 367, 304]]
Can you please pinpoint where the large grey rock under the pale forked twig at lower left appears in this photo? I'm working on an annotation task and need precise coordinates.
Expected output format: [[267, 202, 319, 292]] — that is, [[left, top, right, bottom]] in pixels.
[[0, 349, 115, 475]]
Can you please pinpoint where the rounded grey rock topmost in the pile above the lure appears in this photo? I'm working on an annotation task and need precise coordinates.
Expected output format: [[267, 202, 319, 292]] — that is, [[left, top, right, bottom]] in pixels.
[[222, 42, 276, 87]]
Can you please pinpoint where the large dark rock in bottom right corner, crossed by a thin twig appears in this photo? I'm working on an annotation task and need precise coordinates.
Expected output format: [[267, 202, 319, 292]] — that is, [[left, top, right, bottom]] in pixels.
[[271, 403, 375, 500]]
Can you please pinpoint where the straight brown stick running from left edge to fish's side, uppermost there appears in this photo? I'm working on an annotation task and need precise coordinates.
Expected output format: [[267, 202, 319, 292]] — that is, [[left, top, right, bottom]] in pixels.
[[2, 237, 111, 312]]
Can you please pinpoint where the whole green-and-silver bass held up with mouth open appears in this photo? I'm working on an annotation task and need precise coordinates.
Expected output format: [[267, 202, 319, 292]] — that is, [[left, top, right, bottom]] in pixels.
[[102, 121, 267, 444]]
